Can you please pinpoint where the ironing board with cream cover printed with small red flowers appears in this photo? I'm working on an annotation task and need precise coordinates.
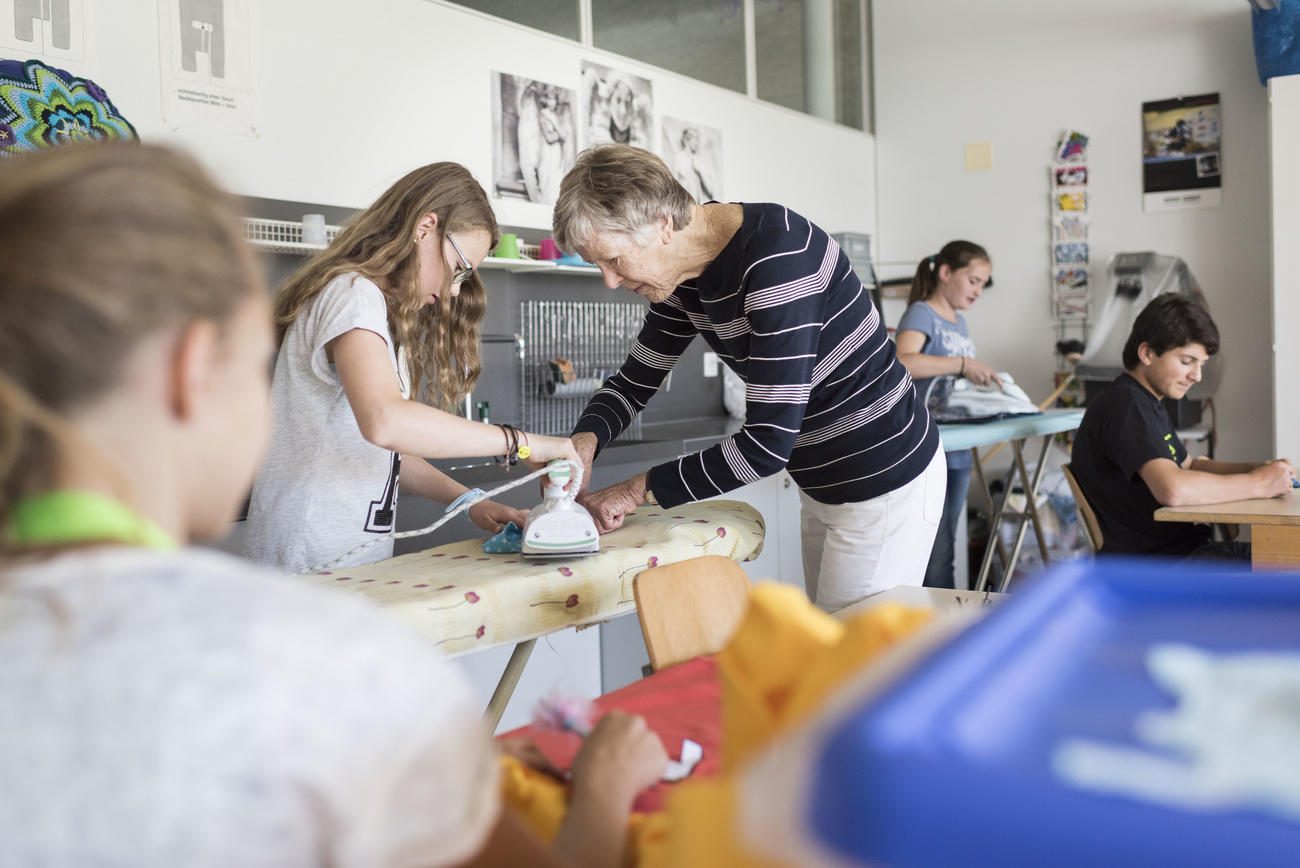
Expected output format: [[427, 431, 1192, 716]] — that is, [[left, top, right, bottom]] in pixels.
[[299, 500, 763, 728]]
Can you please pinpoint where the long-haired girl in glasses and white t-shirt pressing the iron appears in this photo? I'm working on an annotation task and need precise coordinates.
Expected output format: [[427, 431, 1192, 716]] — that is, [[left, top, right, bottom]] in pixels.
[[243, 162, 576, 572]]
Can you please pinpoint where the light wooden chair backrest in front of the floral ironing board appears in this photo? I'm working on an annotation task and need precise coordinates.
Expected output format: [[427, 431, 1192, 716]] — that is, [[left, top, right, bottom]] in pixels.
[[632, 555, 751, 670]]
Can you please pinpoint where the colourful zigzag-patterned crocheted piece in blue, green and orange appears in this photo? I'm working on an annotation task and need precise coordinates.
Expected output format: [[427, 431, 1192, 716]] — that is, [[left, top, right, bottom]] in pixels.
[[0, 60, 139, 156]]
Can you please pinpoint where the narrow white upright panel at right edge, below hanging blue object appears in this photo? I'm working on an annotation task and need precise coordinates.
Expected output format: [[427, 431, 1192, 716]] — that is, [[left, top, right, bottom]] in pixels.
[[1269, 75, 1300, 461]]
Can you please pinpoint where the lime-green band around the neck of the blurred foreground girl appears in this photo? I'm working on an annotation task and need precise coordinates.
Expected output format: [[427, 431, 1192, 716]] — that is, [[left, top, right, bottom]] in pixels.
[[4, 490, 178, 548]]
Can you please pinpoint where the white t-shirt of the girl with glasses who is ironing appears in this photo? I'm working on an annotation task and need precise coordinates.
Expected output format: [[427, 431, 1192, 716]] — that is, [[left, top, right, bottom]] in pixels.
[[242, 274, 411, 573]]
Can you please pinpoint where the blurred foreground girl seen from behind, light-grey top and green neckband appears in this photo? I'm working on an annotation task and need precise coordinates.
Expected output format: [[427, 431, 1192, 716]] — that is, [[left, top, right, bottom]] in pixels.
[[0, 144, 664, 868]]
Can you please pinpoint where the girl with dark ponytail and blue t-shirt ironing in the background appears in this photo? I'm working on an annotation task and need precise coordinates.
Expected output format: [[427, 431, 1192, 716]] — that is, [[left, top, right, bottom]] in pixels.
[[894, 240, 1001, 587]]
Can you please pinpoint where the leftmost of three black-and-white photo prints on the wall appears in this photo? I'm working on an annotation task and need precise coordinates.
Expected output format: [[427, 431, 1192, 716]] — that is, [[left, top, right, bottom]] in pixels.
[[491, 73, 577, 203]]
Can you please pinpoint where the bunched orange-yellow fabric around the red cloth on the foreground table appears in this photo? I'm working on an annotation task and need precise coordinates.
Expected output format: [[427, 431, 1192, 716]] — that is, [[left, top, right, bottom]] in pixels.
[[502, 582, 933, 868]]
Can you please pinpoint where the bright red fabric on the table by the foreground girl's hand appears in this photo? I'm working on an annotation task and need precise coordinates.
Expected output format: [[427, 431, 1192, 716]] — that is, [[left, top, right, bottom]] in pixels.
[[498, 657, 722, 813]]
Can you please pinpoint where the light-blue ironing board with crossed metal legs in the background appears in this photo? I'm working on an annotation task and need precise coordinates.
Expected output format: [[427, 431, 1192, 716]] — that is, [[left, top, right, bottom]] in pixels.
[[939, 408, 1083, 591]]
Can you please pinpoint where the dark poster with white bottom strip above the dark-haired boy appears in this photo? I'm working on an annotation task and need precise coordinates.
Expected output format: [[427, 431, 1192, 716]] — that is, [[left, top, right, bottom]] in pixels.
[[1141, 94, 1223, 211]]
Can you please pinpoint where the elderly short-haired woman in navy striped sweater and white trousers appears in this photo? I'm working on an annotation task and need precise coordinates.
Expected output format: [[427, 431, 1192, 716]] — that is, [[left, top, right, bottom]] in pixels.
[[554, 144, 946, 611]]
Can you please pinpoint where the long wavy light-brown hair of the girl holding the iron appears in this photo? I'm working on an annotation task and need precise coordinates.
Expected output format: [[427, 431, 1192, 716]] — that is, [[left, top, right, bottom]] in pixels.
[[276, 162, 501, 411]]
